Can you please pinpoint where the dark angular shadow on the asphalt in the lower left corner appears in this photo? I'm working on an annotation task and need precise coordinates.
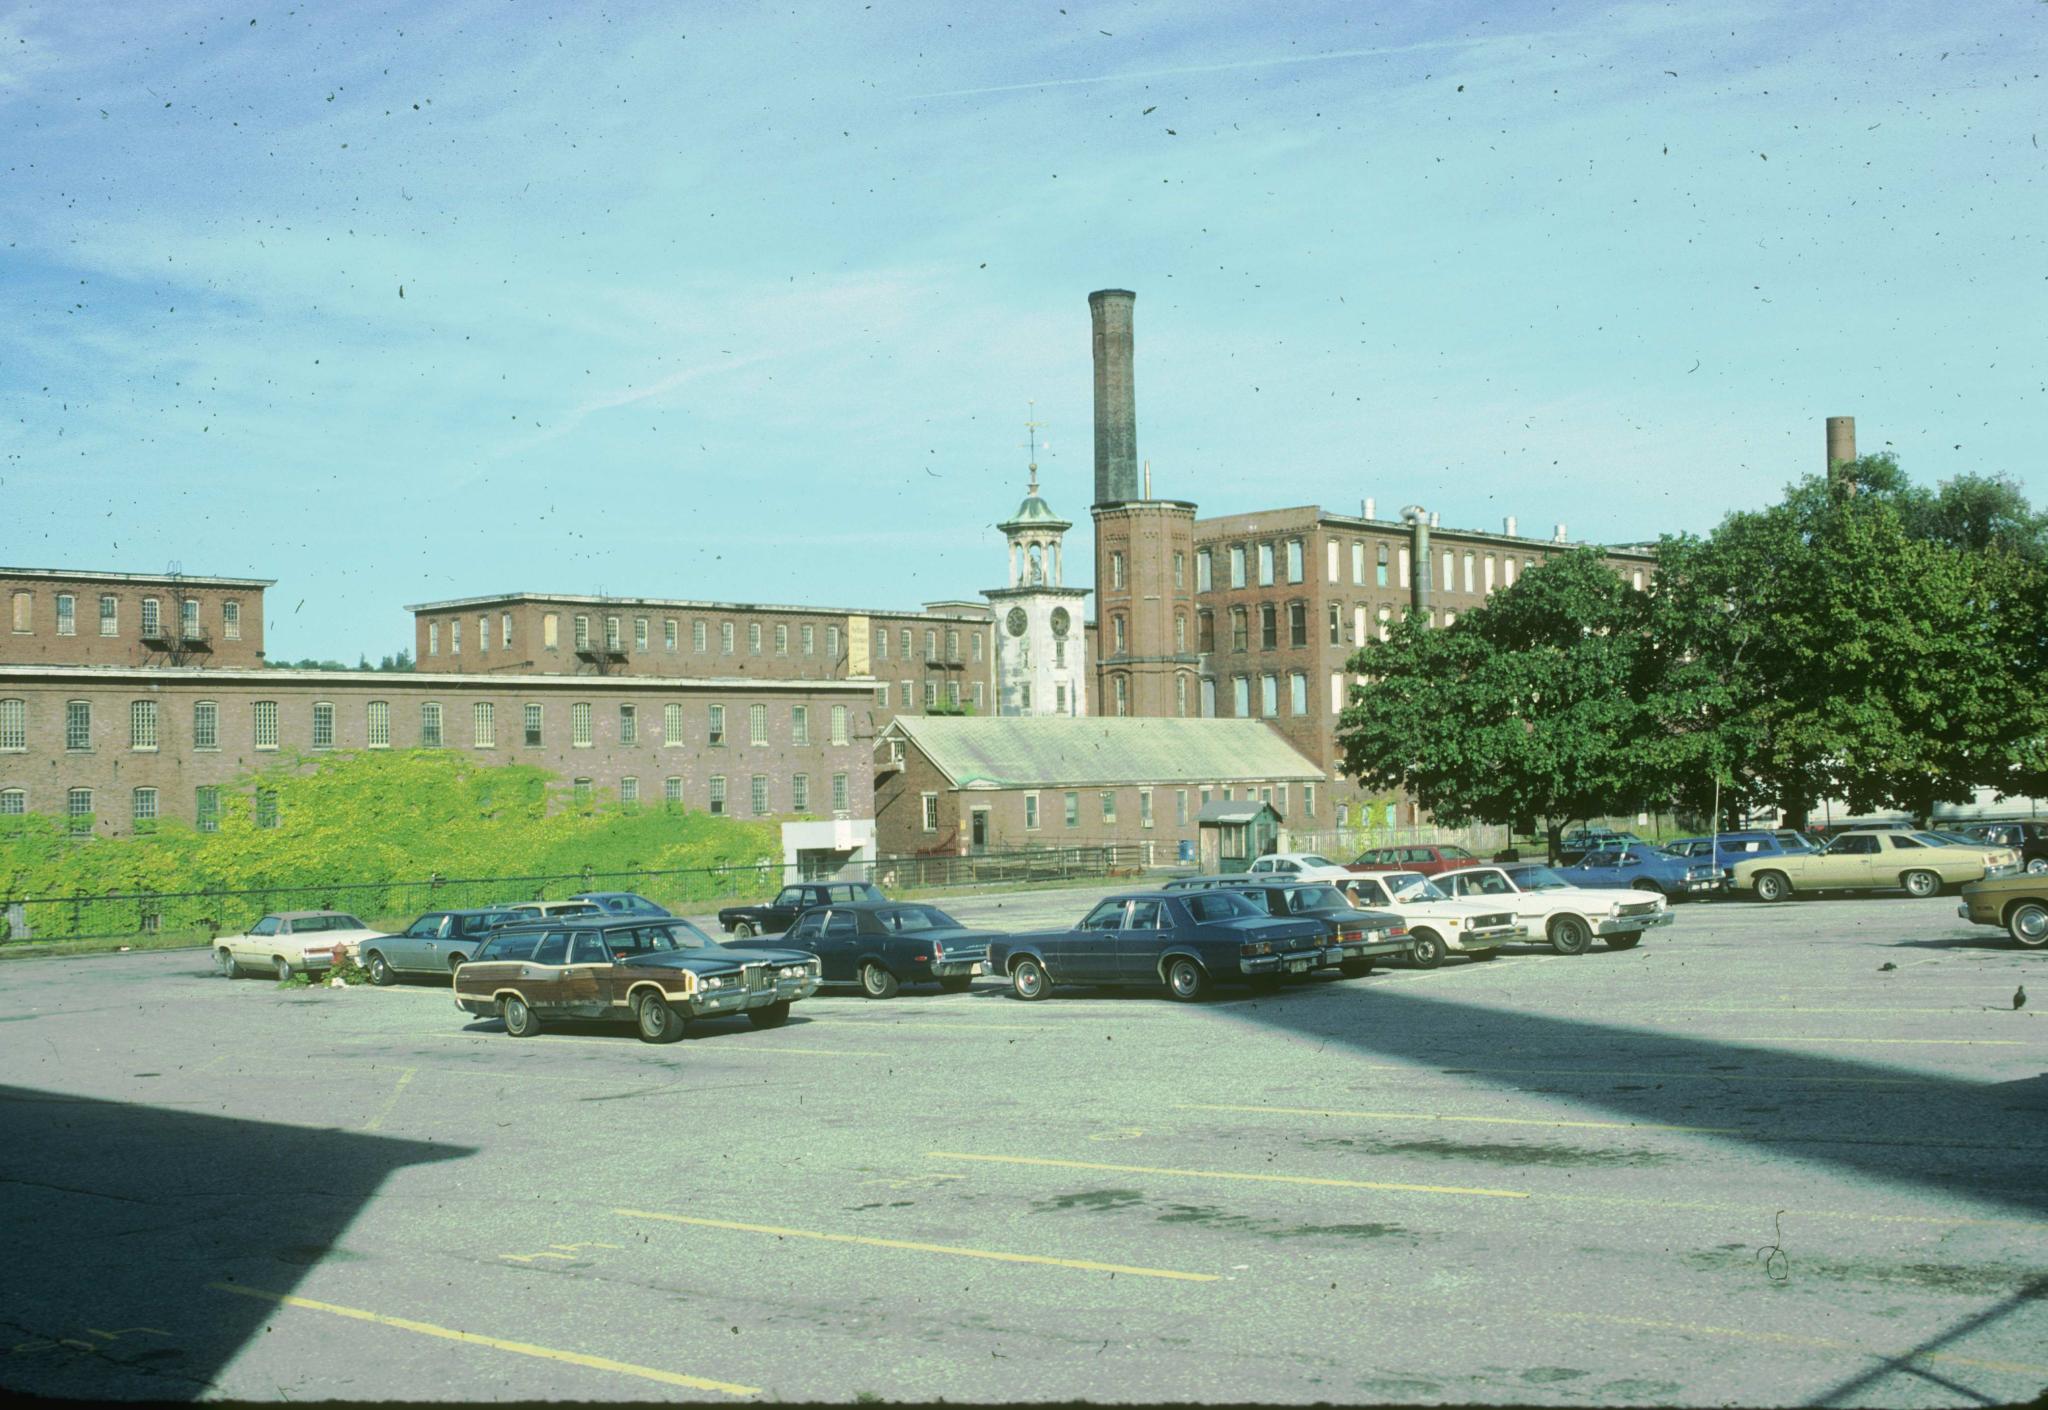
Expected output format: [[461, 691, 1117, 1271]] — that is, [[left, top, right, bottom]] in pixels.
[[0, 1074, 475, 1404]]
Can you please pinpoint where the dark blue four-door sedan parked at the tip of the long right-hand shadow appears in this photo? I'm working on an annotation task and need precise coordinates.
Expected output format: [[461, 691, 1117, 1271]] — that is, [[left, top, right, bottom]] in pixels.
[[989, 891, 1327, 1002]]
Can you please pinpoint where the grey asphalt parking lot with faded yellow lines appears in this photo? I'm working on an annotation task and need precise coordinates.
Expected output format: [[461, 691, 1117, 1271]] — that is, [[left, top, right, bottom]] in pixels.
[[0, 891, 2048, 1406]]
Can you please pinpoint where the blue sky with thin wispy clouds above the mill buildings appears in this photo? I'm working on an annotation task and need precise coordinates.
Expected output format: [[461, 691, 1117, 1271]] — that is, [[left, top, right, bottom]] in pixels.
[[0, 0, 2048, 662]]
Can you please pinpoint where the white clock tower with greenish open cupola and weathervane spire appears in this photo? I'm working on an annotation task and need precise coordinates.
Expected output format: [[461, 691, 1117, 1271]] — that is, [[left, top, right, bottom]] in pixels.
[[981, 409, 1087, 715]]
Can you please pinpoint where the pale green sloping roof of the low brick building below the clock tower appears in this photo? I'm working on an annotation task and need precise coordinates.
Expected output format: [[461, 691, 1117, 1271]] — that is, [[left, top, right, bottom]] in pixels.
[[885, 715, 1323, 789]]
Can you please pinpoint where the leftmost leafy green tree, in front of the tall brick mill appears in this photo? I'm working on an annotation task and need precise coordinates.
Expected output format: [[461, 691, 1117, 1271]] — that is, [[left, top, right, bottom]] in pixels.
[[1337, 549, 1655, 855]]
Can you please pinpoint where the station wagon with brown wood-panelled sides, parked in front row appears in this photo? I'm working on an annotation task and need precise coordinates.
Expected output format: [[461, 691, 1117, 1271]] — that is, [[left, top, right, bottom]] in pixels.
[[455, 916, 817, 1043]]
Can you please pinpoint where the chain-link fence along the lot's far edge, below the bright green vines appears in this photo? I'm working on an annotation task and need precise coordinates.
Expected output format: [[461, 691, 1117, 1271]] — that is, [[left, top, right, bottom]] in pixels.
[[0, 842, 1153, 943]]
